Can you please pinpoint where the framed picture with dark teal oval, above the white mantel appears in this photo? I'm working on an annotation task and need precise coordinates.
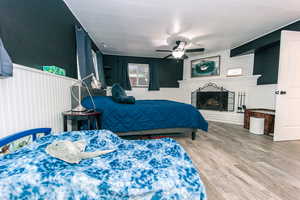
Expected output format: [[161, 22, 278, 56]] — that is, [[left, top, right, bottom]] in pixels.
[[191, 56, 221, 78]]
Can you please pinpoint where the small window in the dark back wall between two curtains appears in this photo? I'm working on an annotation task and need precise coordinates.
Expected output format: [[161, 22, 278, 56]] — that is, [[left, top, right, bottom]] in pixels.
[[128, 63, 149, 87]]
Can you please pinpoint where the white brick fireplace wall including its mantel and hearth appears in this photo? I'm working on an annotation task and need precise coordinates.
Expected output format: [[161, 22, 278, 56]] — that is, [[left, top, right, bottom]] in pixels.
[[180, 50, 276, 124]]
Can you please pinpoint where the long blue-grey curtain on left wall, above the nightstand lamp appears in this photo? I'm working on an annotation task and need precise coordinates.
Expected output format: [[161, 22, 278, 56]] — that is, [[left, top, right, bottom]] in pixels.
[[75, 27, 95, 79]]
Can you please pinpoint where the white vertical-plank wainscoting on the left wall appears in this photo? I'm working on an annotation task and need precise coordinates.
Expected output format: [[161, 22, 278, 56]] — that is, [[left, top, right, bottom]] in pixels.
[[0, 64, 76, 138]]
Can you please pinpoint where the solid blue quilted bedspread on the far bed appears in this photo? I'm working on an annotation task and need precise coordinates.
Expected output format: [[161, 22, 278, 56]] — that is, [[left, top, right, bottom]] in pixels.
[[82, 96, 208, 133]]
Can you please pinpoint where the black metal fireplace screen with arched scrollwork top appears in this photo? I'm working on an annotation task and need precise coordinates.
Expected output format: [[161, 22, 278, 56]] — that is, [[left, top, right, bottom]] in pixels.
[[192, 83, 235, 112]]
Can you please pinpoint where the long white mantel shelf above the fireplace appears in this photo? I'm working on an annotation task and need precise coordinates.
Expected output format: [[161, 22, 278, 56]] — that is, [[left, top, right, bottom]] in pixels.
[[178, 75, 261, 87]]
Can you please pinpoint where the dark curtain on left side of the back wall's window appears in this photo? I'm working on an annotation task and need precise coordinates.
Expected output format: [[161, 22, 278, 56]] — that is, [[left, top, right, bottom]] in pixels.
[[113, 57, 131, 90]]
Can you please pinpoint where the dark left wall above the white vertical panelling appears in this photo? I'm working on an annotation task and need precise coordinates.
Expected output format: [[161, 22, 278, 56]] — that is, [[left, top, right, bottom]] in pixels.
[[0, 0, 96, 78]]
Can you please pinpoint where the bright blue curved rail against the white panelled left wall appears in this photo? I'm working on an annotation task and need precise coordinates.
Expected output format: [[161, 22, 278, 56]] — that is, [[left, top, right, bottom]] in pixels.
[[0, 128, 51, 147]]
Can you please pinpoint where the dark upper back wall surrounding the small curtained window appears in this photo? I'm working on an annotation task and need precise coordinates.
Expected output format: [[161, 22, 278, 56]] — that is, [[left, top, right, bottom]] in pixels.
[[103, 55, 183, 87]]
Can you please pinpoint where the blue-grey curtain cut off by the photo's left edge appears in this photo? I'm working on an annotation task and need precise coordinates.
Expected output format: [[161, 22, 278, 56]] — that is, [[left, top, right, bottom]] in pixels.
[[0, 38, 13, 77]]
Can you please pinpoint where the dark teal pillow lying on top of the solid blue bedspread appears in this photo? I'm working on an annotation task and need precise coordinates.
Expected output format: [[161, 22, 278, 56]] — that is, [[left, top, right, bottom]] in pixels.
[[111, 83, 135, 104]]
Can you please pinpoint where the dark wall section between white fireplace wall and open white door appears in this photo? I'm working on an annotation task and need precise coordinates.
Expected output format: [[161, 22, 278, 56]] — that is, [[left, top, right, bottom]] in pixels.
[[253, 42, 280, 85]]
